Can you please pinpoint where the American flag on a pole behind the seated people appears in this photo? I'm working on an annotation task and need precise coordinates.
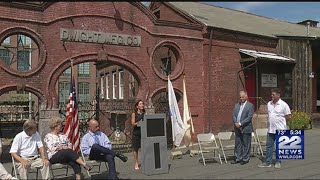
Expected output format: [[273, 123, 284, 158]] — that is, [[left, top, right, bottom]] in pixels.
[[63, 61, 80, 153]]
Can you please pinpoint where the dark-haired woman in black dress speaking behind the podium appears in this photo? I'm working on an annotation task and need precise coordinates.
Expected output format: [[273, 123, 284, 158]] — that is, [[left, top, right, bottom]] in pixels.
[[131, 100, 145, 170]]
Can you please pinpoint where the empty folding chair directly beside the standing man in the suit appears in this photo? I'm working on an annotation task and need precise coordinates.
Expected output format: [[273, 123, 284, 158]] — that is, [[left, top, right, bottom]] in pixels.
[[218, 132, 235, 163]]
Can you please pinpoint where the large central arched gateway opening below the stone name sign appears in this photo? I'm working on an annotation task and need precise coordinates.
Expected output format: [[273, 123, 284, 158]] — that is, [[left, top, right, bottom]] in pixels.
[[55, 61, 141, 150]]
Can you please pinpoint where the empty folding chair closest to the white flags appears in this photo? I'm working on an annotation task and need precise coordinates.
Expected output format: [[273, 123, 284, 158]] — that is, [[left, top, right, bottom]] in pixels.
[[197, 133, 222, 166]]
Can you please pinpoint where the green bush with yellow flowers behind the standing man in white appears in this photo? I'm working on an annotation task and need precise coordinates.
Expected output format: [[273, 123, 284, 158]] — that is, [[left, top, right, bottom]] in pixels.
[[288, 111, 311, 130]]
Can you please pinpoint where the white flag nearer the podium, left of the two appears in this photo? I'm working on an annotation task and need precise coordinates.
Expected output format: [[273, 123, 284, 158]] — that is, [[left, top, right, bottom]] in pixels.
[[168, 76, 185, 147]]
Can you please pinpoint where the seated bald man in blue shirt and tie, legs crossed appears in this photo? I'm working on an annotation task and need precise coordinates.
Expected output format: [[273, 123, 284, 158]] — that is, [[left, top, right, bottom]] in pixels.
[[80, 119, 128, 179]]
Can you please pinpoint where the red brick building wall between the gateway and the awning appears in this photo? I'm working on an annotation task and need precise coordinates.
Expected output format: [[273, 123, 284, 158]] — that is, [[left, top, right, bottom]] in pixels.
[[203, 31, 275, 133]]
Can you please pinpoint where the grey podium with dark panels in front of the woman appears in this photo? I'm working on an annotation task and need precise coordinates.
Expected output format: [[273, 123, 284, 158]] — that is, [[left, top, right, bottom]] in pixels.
[[138, 114, 169, 175]]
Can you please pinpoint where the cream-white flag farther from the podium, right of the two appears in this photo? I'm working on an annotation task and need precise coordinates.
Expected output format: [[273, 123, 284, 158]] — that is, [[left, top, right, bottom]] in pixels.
[[183, 77, 194, 147]]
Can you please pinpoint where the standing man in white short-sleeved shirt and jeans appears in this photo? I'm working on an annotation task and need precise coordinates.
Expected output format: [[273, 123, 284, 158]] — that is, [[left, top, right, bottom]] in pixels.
[[258, 89, 291, 168]]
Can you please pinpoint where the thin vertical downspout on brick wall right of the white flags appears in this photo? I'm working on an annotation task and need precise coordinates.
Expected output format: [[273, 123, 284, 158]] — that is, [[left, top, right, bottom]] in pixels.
[[207, 29, 213, 133]]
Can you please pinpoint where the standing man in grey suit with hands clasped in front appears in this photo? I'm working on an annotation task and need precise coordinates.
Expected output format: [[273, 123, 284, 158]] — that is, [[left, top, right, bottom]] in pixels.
[[231, 91, 254, 165]]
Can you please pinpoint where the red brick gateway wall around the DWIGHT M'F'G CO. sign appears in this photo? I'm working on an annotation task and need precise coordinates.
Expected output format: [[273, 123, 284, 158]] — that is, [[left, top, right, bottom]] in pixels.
[[0, 2, 204, 132]]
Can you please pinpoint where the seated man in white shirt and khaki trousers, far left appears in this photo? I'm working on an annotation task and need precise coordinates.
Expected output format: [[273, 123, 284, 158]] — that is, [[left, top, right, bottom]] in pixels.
[[10, 120, 50, 179]]
